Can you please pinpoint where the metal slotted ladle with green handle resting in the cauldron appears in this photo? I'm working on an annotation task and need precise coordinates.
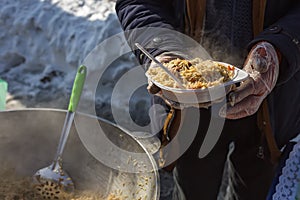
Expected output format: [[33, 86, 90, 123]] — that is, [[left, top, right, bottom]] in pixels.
[[33, 66, 87, 200]]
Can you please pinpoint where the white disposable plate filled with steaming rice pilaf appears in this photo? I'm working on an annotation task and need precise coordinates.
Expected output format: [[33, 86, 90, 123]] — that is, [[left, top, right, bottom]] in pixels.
[[146, 58, 249, 103]]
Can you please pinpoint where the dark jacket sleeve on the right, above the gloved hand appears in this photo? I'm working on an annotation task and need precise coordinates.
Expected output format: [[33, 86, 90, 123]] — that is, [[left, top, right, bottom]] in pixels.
[[251, 3, 300, 86]]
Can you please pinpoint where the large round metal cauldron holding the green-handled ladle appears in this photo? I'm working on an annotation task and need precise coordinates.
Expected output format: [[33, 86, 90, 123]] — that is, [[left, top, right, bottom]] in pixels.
[[0, 109, 159, 200]]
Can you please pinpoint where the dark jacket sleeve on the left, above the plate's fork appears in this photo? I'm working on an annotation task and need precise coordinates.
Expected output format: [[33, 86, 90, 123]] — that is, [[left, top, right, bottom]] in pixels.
[[115, 0, 186, 64]]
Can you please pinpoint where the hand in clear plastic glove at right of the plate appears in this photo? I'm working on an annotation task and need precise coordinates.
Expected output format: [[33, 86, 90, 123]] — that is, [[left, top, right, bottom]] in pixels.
[[220, 41, 279, 119]]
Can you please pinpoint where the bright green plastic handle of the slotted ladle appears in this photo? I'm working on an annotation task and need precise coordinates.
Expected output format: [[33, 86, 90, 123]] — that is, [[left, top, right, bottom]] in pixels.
[[68, 65, 87, 112]]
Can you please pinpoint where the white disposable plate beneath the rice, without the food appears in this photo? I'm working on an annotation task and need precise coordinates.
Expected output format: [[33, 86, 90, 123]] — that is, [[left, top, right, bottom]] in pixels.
[[146, 62, 249, 104]]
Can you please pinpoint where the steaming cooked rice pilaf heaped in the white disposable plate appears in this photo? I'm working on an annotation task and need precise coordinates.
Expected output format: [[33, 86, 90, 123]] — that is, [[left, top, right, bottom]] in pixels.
[[147, 58, 234, 89]]
